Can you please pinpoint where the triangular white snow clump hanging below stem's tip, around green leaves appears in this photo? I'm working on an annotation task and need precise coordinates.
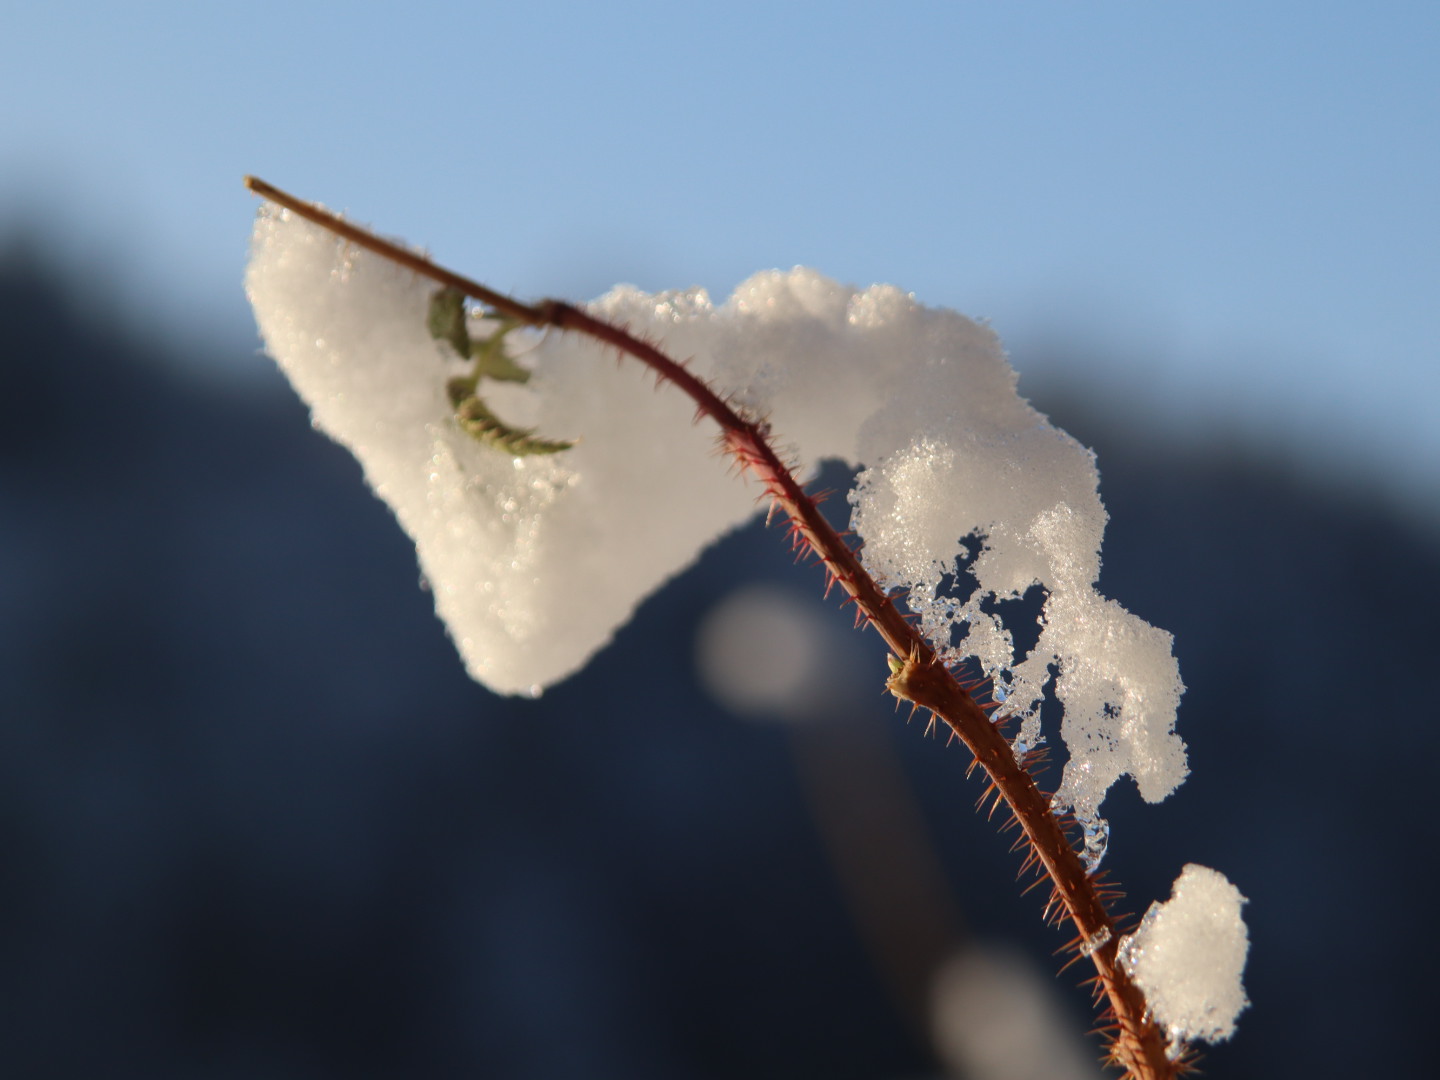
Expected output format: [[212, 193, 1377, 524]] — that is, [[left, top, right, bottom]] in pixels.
[[246, 206, 756, 694]]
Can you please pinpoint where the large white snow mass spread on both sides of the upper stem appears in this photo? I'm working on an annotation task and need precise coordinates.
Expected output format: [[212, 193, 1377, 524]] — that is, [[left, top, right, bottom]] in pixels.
[[246, 207, 1187, 835]]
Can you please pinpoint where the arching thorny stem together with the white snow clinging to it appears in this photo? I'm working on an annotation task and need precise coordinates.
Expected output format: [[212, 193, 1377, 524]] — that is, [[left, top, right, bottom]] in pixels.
[[246, 179, 1244, 1077]]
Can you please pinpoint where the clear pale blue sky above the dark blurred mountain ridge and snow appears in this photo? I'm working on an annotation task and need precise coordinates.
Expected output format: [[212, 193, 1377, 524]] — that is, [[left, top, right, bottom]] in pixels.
[[0, 0, 1440, 515]]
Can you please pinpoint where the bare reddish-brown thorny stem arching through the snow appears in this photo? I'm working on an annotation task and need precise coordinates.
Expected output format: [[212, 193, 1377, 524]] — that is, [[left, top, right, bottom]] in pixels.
[[245, 176, 1184, 1080]]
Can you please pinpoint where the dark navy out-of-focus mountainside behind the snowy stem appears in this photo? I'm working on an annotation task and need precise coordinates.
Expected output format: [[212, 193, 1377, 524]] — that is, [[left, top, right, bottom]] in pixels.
[[0, 248, 1440, 1080]]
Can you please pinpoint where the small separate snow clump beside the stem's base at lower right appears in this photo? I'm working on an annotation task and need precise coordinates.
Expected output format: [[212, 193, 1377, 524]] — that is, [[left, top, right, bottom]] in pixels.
[[1119, 863, 1250, 1045]]
